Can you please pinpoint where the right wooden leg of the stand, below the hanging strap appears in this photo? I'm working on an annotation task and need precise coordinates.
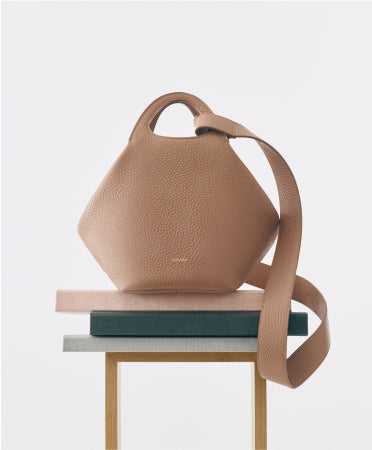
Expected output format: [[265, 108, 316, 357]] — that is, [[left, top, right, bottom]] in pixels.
[[252, 361, 267, 450]]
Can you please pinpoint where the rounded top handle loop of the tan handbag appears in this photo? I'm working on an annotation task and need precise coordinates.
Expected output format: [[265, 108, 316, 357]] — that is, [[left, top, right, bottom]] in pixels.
[[129, 92, 212, 141]]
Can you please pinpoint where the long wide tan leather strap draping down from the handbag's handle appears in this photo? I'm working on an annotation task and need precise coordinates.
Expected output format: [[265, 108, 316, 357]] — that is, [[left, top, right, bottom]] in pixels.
[[194, 113, 330, 388]]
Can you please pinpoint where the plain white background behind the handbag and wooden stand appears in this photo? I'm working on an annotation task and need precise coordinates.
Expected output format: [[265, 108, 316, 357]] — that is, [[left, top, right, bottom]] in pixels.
[[2, 2, 372, 450]]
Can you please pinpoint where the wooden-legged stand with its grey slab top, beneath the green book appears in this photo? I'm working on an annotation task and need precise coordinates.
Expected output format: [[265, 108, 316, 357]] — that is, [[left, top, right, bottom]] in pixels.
[[63, 335, 267, 450]]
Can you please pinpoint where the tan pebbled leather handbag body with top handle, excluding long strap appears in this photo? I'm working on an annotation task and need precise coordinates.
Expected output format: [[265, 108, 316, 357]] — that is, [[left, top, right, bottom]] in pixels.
[[79, 94, 279, 293]]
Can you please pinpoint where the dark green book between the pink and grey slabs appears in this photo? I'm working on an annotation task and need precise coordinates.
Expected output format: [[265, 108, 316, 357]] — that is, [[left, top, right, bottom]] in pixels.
[[90, 311, 308, 337]]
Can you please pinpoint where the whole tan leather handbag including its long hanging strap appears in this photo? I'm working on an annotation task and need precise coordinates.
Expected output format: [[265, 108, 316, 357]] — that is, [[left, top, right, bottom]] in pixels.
[[78, 92, 330, 387]]
